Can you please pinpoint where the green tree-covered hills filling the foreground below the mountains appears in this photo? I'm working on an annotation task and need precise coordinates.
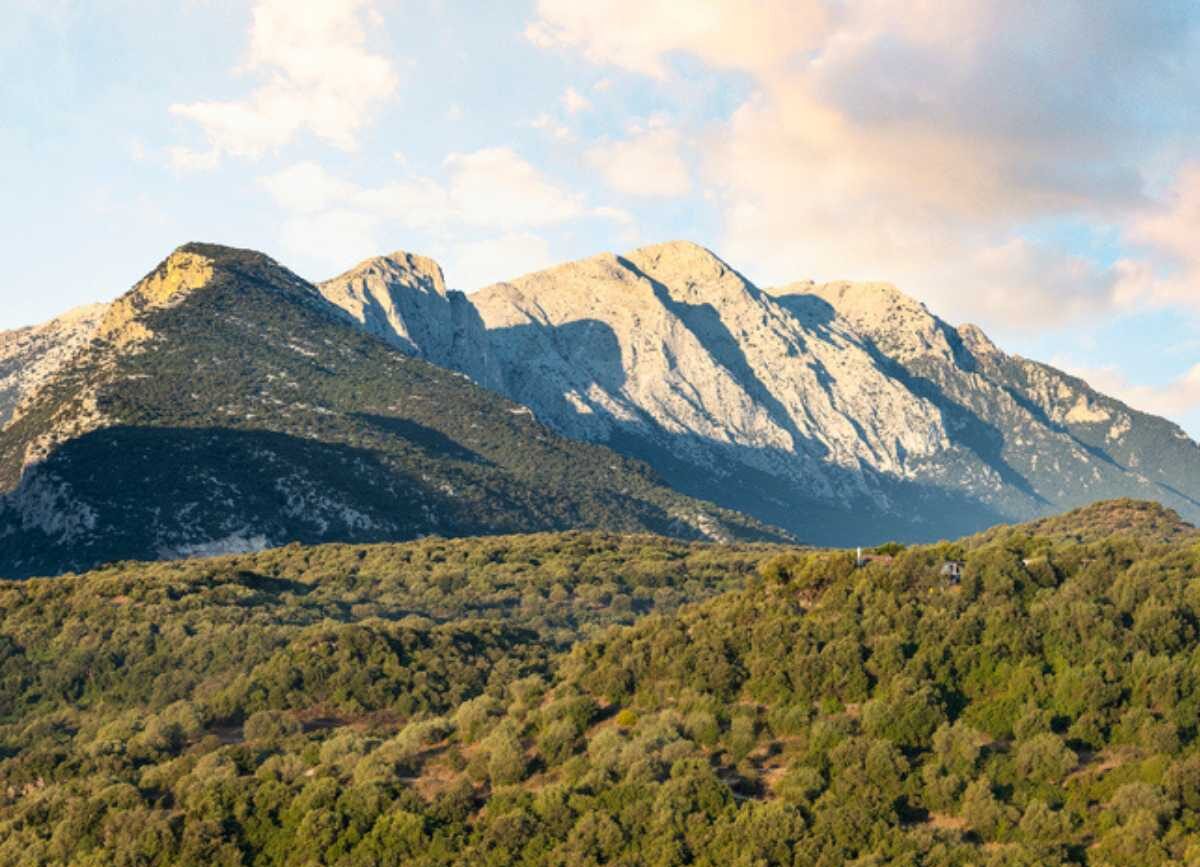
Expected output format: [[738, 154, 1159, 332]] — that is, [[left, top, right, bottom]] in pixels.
[[0, 503, 1200, 866]]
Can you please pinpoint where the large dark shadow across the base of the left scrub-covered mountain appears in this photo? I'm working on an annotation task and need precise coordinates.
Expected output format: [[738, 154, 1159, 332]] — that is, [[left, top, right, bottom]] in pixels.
[[0, 426, 446, 578]]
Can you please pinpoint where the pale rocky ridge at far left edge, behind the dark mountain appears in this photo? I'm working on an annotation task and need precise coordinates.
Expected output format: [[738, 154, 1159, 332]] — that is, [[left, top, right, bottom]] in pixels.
[[0, 304, 108, 429]]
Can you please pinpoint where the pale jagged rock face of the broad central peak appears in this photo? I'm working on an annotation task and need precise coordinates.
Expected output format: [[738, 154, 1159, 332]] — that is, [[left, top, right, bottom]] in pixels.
[[472, 244, 944, 498]]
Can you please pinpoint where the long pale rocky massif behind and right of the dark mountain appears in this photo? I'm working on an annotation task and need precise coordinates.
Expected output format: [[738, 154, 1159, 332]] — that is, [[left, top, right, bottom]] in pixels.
[[323, 241, 1200, 544]]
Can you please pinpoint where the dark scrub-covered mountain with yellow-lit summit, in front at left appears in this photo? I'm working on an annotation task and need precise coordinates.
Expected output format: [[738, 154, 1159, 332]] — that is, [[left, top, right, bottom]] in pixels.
[[0, 244, 778, 576]]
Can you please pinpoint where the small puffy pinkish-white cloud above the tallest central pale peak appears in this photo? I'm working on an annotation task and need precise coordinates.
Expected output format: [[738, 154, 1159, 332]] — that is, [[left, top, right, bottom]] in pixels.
[[584, 128, 691, 198]]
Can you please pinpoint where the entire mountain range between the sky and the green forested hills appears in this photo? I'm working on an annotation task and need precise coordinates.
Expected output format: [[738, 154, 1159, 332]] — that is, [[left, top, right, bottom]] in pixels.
[[0, 241, 1200, 576]]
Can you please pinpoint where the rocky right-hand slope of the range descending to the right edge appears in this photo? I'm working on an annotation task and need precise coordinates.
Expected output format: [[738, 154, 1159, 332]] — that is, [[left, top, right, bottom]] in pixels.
[[792, 277, 1200, 533]]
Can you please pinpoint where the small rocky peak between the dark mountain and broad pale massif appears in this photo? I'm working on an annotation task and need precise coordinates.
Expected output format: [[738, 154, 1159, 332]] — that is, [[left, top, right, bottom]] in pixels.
[[318, 252, 500, 389]]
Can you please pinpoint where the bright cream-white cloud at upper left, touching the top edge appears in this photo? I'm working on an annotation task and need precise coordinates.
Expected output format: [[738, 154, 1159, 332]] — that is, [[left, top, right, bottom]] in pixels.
[[170, 0, 398, 171]]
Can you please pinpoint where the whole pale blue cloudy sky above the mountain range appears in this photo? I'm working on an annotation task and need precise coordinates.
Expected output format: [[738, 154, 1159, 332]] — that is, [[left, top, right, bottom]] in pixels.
[[0, 0, 1200, 437]]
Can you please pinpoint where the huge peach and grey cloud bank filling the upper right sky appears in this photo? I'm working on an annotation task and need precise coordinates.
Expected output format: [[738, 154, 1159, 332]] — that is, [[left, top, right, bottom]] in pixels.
[[527, 0, 1200, 328]]
